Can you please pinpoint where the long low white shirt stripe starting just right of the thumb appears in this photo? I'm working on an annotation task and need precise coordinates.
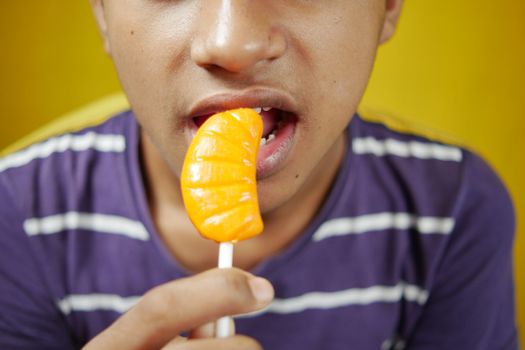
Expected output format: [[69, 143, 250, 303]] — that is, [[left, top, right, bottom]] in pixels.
[[236, 282, 428, 318]]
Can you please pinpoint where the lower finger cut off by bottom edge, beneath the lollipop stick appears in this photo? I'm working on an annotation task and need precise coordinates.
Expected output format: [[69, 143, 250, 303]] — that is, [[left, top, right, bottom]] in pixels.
[[162, 335, 263, 350]]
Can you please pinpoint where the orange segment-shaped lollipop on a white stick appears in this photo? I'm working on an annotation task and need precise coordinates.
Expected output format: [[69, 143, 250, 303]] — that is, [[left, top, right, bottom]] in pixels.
[[181, 108, 263, 337]]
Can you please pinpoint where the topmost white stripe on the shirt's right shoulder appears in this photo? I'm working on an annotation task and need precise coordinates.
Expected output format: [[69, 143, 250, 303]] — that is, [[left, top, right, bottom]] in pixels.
[[352, 137, 463, 162]]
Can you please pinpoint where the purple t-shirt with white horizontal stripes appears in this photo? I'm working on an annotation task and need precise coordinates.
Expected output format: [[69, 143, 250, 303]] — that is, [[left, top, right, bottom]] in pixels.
[[0, 112, 518, 350]]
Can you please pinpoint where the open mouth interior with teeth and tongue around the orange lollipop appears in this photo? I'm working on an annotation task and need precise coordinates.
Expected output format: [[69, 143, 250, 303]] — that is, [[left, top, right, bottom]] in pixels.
[[192, 107, 297, 179]]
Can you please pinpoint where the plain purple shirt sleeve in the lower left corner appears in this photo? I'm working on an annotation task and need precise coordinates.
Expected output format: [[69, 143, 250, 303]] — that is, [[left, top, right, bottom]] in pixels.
[[0, 173, 75, 350]]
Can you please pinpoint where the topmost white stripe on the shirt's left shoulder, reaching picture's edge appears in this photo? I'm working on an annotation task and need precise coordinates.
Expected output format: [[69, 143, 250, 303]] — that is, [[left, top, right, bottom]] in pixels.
[[0, 132, 126, 172]]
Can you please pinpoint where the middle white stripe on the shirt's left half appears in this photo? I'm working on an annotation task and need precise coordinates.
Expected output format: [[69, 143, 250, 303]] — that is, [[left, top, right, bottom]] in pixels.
[[24, 212, 149, 241]]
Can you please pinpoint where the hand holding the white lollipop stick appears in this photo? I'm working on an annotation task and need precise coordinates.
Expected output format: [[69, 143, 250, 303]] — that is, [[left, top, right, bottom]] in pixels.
[[84, 269, 273, 350]]
